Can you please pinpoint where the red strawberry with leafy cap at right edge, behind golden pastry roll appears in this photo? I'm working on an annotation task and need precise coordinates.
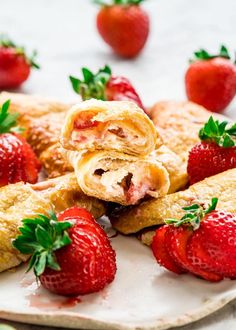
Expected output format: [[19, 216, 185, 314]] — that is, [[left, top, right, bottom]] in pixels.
[[187, 117, 236, 184]]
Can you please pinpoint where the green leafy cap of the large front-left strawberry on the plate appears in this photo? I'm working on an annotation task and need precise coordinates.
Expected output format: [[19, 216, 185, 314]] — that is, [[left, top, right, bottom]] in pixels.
[[12, 212, 72, 277]]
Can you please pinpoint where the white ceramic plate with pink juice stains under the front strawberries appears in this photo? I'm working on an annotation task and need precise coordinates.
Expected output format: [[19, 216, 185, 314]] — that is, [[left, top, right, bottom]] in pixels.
[[0, 219, 236, 330]]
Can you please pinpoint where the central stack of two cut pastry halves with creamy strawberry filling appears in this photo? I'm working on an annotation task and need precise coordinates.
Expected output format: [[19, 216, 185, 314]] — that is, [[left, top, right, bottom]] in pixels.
[[60, 100, 170, 205]]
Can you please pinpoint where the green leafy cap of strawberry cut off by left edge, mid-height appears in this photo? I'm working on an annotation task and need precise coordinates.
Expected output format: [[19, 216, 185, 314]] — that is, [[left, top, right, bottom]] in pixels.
[[0, 100, 24, 134]]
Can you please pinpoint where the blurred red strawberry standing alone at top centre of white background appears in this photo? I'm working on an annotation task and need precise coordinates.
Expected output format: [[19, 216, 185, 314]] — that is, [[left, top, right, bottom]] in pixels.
[[94, 0, 150, 58]]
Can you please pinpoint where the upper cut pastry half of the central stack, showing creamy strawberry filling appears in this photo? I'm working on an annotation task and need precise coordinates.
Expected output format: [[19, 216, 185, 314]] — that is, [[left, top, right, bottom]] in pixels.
[[61, 100, 161, 156]]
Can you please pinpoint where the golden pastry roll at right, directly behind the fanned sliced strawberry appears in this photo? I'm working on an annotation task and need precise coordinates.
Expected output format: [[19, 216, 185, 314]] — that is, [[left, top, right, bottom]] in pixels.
[[112, 169, 236, 234]]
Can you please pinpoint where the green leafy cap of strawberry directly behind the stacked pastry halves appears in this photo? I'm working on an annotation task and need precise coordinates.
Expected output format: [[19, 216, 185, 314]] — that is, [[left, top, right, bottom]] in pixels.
[[69, 65, 111, 101]]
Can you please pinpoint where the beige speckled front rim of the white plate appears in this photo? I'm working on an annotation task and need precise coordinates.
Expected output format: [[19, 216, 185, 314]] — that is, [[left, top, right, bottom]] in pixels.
[[0, 290, 236, 330]]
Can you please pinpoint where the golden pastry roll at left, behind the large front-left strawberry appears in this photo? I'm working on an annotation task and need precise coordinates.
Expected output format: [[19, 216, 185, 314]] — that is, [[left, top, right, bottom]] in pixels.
[[0, 174, 105, 272]]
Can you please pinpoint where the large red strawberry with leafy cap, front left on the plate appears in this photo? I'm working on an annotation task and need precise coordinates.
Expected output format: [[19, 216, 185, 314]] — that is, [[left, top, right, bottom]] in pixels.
[[13, 207, 116, 296]]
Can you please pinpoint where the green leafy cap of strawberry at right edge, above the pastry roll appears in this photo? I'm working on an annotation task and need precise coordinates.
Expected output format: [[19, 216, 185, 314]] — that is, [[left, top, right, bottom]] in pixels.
[[199, 116, 236, 148]]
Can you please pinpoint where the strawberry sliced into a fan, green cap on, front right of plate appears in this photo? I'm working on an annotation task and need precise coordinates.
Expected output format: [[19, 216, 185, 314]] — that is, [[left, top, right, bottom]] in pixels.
[[152, 198, 236, 282]]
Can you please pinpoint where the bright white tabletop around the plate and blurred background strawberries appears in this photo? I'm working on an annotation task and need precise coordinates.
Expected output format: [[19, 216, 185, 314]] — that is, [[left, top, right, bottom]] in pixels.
[[0, 0, 236, 330]]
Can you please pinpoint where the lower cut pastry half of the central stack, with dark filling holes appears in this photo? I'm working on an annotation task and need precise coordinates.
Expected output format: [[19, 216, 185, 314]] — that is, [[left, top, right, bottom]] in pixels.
[[67, 150, 169, 205]]
